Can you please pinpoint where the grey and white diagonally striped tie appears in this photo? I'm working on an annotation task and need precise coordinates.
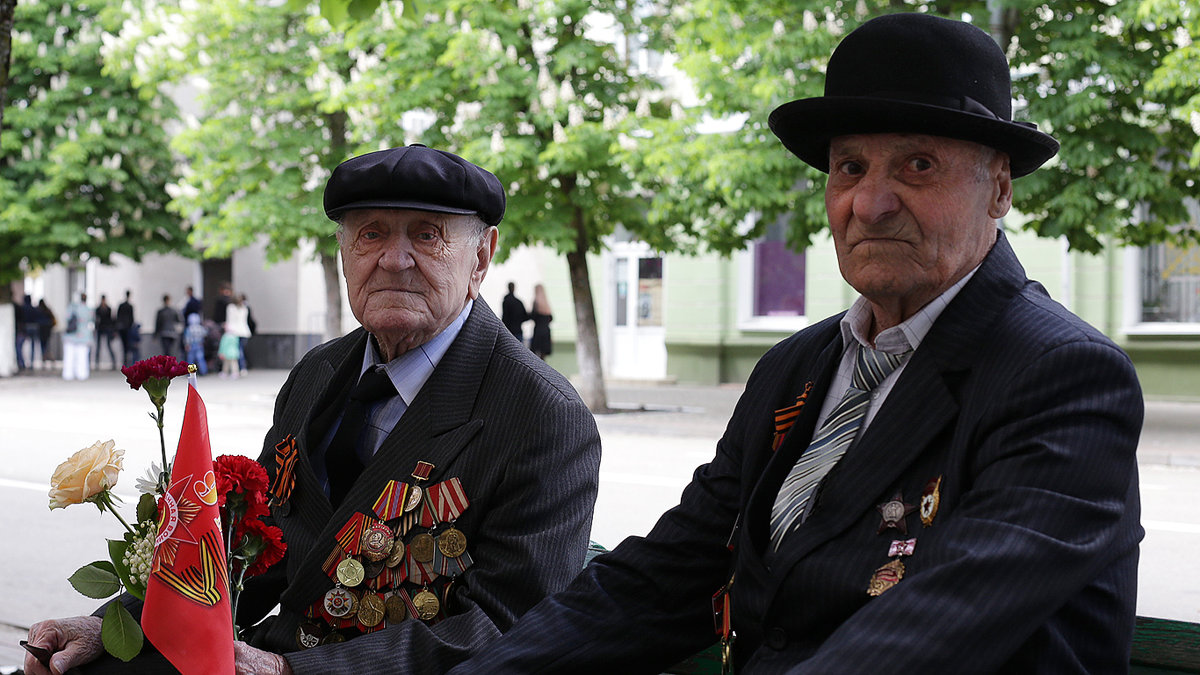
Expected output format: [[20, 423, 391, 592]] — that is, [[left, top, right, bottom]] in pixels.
[[770, 345, 912, 550]]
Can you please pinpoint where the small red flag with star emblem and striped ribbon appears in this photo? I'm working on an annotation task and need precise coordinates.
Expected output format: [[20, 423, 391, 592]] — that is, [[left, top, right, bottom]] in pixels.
[[142, 384, 234, 675]]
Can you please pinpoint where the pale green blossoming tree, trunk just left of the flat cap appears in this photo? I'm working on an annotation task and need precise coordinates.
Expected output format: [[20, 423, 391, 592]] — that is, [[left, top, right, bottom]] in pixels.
[[109, 0, 353, 336]]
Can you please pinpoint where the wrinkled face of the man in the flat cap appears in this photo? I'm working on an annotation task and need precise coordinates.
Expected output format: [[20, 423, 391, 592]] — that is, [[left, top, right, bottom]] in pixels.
[[340, 209, 497, 359]]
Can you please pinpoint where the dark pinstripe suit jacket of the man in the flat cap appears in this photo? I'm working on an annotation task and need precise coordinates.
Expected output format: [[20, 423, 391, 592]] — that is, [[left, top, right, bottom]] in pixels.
[[240, 299, 600, 673]]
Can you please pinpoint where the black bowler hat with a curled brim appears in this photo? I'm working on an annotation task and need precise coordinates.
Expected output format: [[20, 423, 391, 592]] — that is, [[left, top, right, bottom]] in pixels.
[[768, 13, 1058, 178]]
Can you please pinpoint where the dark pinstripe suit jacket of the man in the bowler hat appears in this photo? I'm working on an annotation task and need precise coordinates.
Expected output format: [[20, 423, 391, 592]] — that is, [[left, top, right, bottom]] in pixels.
[[454, 235, 1142, 675]]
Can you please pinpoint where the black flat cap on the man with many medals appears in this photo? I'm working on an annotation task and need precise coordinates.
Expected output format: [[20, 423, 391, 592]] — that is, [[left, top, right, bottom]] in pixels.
[[325, 144, 504, 225]]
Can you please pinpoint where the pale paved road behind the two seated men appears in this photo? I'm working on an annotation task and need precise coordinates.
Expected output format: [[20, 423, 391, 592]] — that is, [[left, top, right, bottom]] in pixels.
[[0, 371, 1200, 673]]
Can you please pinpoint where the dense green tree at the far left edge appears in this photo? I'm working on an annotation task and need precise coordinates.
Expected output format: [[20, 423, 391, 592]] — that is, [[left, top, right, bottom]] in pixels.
[[0, 0, 186, 294]]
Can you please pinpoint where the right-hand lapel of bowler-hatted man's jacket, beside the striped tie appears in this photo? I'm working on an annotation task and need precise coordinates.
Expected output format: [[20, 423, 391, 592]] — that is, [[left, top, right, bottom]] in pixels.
[[768, 233, 1025, 566]]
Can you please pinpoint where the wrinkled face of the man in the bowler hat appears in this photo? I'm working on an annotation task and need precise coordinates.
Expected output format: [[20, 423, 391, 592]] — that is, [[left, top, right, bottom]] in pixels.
[[826, 133, 1012, 323]]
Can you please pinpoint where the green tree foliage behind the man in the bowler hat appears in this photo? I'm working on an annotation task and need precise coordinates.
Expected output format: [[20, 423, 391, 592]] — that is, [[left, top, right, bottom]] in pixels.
[[671, 0, 1200, 252]]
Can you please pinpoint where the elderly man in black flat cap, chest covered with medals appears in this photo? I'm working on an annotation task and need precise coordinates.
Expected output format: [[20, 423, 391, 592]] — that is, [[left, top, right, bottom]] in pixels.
[[25, 145, 600, 674]]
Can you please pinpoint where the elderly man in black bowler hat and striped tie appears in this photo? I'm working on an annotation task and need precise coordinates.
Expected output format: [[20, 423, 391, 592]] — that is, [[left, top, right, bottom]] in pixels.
[[452, 14, 1142, 675]]
